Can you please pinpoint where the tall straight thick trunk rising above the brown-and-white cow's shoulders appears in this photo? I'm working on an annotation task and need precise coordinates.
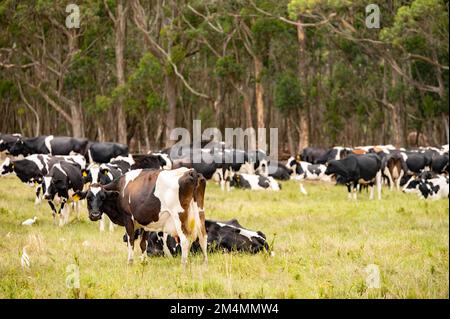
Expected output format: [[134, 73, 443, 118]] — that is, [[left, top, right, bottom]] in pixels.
[[114, 0, 128, 144]]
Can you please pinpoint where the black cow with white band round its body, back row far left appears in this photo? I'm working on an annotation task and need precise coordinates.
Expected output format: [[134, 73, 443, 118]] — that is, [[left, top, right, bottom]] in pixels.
[[10, 135, 88, 156]]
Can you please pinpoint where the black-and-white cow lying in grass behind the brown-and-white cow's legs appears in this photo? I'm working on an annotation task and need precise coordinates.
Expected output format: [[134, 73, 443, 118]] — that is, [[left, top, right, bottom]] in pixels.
[[146, 219, 269, 256]]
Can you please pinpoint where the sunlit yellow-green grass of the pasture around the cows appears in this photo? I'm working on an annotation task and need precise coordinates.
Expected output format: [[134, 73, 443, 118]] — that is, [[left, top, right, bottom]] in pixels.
[[0, 177, 449, 298]]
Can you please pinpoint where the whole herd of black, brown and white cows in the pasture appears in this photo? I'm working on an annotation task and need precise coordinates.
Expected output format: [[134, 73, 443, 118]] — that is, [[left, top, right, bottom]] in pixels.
[[0, 134, 449, 263]]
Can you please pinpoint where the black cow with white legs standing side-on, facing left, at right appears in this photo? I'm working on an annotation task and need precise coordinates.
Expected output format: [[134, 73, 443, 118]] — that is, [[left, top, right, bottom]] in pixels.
[[325, 154, 381, 200]]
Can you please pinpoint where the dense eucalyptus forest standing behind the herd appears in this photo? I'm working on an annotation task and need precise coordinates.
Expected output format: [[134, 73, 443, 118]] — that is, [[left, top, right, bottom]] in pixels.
[[0, 0, 449, 154]]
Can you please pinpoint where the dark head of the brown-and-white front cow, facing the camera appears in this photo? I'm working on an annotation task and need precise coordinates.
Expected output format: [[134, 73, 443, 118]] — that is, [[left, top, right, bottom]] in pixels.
[[74, 184, 119, 221]]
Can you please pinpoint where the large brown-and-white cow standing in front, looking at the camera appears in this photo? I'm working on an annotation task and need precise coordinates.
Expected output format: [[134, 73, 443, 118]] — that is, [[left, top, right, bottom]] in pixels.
[[76, 167, 208, 264]]
